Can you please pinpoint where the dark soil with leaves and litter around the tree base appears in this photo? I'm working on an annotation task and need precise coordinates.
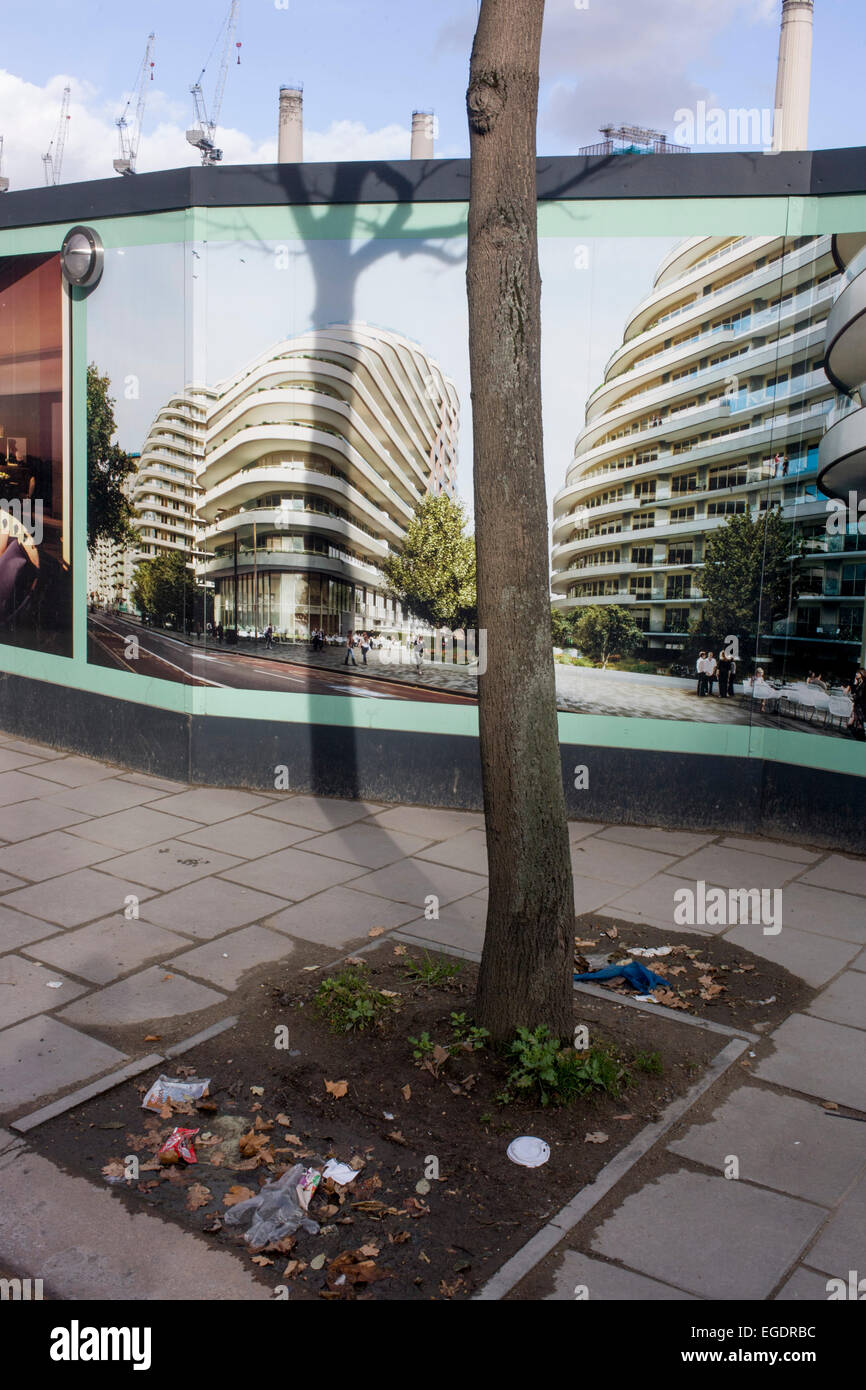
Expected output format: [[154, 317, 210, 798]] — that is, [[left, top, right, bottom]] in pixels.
[[29, 945, 745, 1301]]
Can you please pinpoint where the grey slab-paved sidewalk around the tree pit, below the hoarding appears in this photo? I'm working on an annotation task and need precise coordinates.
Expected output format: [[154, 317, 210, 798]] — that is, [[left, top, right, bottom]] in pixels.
[[0, 735, 866, 1298]]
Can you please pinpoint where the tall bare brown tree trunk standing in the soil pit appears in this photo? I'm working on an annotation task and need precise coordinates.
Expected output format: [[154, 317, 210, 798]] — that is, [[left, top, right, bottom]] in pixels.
[[466, 0, 574, 1040]]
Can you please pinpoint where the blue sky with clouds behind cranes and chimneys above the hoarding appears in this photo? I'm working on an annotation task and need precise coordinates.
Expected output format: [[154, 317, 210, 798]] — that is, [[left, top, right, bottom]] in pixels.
[[0, 0, 866, 188]]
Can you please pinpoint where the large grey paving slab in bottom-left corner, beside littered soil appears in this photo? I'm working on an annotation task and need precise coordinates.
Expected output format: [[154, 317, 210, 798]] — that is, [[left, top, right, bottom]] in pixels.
[[1, 1145, 272, 1295]]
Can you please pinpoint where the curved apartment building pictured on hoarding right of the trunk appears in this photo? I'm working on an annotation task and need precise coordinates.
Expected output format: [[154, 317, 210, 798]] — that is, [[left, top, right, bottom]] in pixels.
[[552, 236, 863, 656]]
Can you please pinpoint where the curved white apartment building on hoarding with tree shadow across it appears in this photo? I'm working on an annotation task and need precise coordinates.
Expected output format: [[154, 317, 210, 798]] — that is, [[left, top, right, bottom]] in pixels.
[[196, 322, 459, 637]]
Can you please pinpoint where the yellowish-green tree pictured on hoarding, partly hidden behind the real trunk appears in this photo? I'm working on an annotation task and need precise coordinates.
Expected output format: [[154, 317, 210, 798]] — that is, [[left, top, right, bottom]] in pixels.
[[385, 492, 475, 632]]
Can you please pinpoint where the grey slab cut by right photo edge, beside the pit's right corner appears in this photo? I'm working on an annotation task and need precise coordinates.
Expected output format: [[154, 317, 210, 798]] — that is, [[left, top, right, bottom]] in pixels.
[[755, 1013, 866, 1106]]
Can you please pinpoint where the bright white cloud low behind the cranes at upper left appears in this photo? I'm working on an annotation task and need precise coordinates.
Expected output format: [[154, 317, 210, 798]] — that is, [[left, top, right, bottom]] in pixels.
[[0, 70, 410, 189]]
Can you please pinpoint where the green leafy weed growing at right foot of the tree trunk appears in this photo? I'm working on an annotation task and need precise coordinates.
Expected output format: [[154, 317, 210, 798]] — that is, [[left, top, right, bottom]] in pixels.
[[496, 1023, 631, 1105]]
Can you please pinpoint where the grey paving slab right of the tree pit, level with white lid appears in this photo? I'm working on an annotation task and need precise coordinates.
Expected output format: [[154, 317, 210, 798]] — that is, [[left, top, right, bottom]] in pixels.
[[669, 1084, 866, 1207]]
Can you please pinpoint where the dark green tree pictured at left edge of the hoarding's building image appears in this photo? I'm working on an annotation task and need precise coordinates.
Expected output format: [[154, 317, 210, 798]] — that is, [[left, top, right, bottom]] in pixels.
[[88, 363, 136, 549]]
